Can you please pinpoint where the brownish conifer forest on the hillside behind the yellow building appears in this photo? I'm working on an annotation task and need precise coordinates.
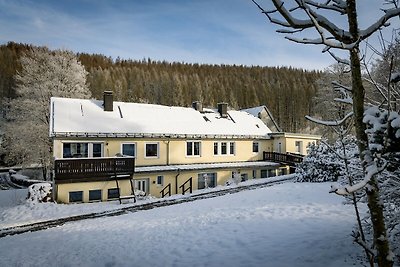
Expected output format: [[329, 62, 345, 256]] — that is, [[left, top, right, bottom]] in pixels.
[[0, 42, 322, 133]]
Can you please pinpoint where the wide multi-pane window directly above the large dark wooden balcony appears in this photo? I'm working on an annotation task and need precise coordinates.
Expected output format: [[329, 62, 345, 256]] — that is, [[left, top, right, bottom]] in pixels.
[[63, 143, 104, 158]]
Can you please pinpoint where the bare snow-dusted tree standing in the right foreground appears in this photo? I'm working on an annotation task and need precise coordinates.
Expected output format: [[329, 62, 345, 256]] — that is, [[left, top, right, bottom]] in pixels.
[[252, 0, 400, 266]]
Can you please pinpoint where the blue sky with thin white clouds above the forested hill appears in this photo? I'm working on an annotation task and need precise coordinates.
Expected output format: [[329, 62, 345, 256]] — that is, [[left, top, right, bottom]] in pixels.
[[0, 0, 398, 69]]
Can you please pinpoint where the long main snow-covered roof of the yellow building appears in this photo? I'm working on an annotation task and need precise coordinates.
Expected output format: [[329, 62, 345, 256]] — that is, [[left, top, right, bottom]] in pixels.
[[50, 97, 271, 139]]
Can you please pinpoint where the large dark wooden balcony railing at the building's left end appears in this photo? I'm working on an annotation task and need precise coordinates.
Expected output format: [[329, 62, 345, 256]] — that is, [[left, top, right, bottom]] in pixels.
[[54, 157, 135, 182]]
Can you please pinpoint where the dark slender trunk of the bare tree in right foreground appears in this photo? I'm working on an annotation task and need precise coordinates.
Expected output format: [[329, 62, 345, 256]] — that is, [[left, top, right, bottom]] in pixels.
[[347, 0, 393, 267]]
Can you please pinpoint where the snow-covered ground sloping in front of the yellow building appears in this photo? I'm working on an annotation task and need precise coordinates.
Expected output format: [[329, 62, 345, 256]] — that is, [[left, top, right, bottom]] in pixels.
[[0, 183, 362, 267]]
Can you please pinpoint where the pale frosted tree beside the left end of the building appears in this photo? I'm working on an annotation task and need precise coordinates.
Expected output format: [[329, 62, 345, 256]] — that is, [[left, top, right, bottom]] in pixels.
[[2, 48, 90, 180]]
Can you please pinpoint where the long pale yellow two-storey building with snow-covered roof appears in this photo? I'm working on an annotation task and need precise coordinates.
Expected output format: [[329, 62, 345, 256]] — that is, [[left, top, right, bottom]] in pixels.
[[50, 92, 319, 203]]
